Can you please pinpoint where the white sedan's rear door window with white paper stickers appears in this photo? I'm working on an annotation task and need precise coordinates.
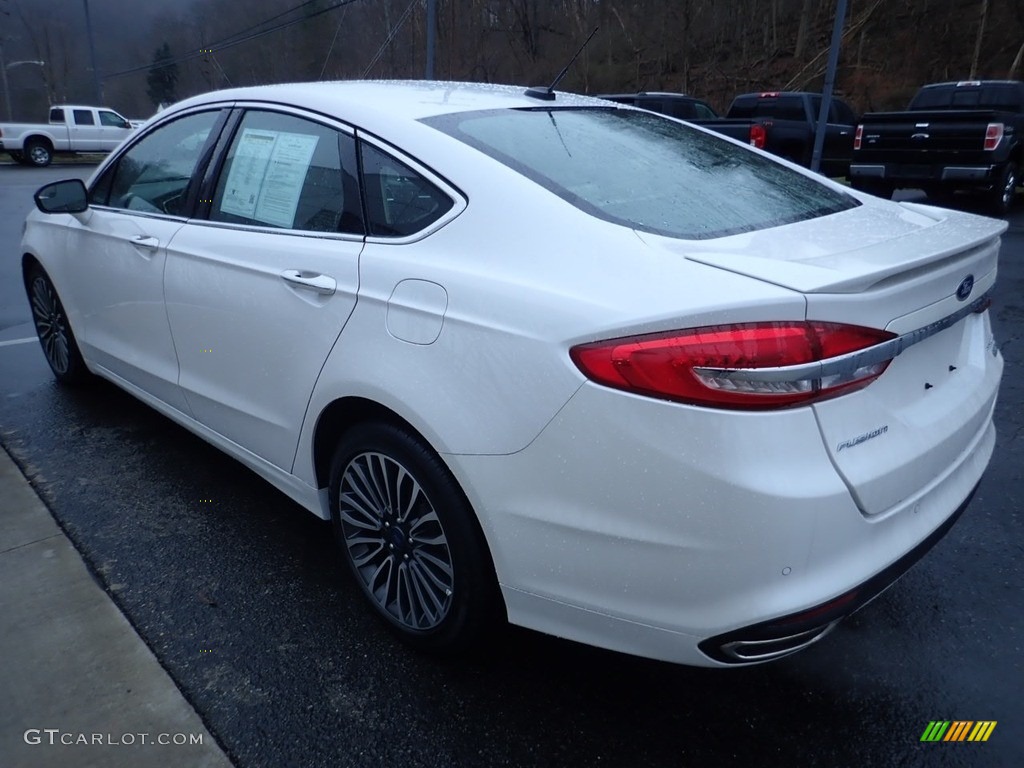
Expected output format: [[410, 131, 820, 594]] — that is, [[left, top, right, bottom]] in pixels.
[[210, 111, 362, 234]]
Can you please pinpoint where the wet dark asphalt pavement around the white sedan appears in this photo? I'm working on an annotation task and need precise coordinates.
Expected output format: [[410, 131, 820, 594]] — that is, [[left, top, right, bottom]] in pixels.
[[0, 168, 1024, 768]]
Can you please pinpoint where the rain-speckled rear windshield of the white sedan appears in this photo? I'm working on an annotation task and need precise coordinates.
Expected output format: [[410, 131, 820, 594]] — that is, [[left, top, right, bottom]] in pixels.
[[423, 108, 859, 240]]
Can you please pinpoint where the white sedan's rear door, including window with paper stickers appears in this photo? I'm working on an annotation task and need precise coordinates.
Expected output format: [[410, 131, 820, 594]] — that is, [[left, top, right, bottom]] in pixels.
[[164, 109, 364, 470]]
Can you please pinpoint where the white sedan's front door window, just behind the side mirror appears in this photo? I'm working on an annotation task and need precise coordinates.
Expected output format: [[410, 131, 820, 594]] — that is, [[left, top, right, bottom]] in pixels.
[[95, 111, 220, 216]]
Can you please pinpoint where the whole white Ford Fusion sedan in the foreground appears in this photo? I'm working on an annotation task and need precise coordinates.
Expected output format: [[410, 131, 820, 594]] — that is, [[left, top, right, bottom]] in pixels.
[[22, 82, 1006, 667]]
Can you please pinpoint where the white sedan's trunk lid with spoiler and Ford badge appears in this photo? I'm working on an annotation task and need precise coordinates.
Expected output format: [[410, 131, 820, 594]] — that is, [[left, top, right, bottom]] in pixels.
[[643, 199, 1007, 516]]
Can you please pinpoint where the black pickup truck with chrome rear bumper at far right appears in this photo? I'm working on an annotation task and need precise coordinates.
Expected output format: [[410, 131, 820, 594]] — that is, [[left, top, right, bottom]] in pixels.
[[850, 80, 1024, 215]]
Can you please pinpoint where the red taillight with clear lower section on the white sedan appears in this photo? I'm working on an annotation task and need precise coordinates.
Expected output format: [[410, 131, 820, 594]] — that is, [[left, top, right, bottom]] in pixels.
[[569, 322, 895, 410]]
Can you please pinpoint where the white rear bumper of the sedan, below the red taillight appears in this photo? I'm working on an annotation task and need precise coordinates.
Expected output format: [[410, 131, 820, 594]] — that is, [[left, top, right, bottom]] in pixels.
[[445, 384, 995, 667]]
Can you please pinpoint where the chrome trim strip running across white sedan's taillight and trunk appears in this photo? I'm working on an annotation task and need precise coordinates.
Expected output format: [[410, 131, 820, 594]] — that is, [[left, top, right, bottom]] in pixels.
[[693, 291, 991, 383]]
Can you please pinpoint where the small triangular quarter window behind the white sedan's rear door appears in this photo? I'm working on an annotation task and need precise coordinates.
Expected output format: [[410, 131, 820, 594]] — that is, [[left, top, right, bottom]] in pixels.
[[361, 142, 455, 238]]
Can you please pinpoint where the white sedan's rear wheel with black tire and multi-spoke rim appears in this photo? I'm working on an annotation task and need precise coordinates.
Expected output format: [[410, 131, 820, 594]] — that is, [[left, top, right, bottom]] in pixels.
[[330, 422, 501, 653]]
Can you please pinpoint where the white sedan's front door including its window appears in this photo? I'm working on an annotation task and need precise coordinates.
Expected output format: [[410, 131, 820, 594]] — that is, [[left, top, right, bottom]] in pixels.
[[68, 109, 229, 413]]
